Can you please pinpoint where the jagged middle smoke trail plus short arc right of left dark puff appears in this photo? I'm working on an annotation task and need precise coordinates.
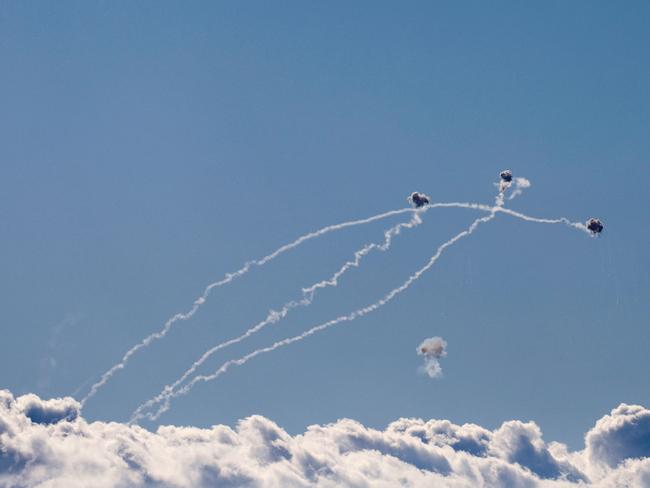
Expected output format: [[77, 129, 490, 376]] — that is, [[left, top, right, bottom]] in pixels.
[[132, 202, 490, 419]]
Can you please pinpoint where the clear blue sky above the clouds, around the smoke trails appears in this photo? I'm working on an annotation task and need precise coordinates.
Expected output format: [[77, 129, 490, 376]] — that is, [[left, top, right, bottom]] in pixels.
[[0, 1, 650, 448]]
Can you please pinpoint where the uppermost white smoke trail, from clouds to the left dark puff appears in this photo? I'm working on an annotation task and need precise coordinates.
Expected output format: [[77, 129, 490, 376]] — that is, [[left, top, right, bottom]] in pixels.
[[80, 205, 430, 408]]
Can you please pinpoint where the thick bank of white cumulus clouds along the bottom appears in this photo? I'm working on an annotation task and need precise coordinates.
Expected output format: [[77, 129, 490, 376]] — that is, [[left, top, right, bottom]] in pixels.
[[0, 390, 650, 488]]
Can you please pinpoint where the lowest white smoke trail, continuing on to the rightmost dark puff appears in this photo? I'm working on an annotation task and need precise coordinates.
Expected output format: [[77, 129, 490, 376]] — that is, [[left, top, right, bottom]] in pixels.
[[131, 204, 588, 422]]
